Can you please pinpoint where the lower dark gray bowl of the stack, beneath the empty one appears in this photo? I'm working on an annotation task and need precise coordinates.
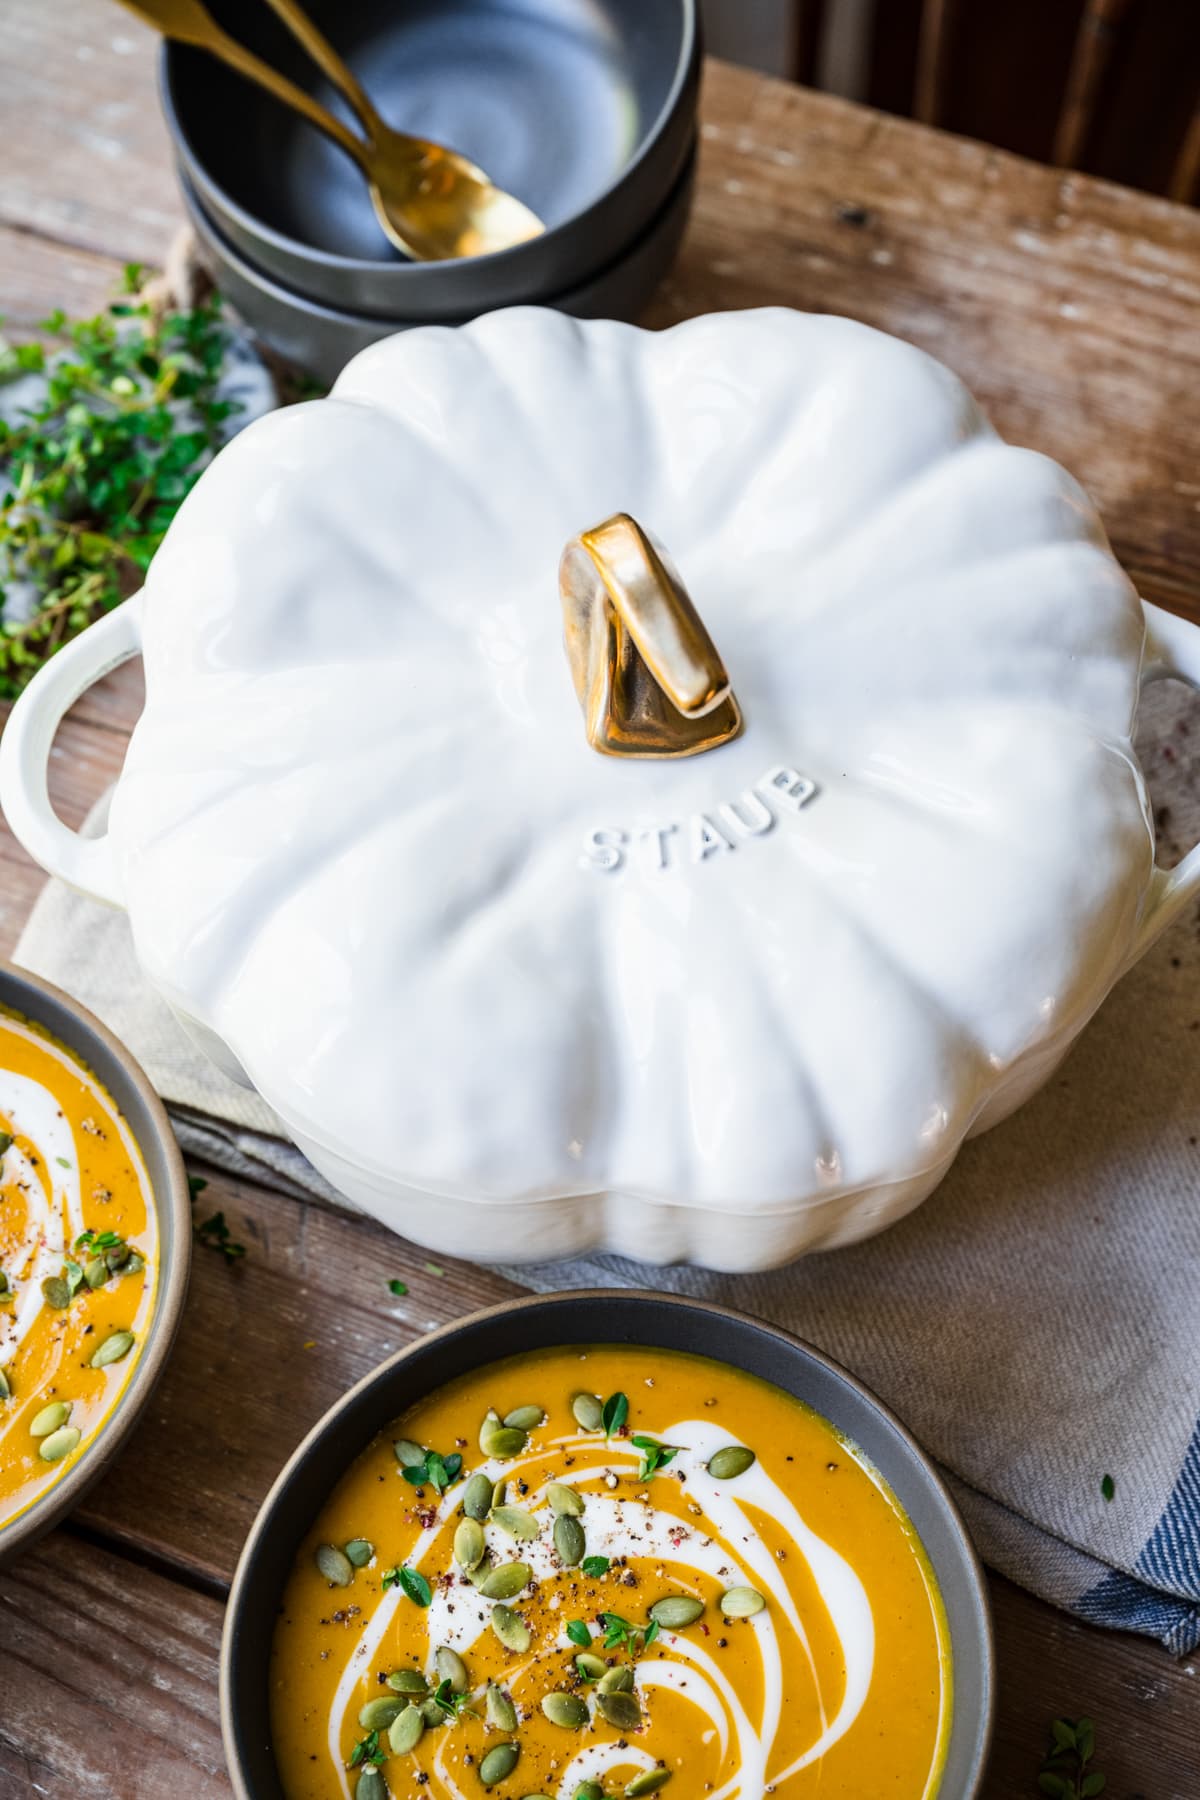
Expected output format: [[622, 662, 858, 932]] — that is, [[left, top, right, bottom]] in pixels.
[[180, 148, 696, 383]]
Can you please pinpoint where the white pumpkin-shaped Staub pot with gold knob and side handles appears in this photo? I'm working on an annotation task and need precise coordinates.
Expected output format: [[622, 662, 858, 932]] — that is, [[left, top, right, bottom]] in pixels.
[[0, 310, 1200, 1269]]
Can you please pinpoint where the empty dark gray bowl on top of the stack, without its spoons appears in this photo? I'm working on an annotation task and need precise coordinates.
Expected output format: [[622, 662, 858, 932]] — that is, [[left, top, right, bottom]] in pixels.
[[162, 0, 700, 322]]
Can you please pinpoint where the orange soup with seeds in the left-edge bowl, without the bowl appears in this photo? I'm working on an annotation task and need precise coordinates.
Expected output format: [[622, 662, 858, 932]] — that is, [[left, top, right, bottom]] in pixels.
[[0, 1010, 157, 1530]]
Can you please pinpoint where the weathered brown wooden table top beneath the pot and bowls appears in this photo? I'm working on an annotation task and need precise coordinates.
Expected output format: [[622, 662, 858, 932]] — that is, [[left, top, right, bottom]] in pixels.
[[0, 0, 1200, 1800]]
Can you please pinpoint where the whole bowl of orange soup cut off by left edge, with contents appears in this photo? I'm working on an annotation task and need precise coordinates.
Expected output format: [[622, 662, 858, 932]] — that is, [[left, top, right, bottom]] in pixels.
[[0, 965, 191, 1562]]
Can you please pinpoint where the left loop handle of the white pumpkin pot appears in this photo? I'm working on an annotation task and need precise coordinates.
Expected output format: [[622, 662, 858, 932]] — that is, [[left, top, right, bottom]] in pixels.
[[0, 592, 142, 907]]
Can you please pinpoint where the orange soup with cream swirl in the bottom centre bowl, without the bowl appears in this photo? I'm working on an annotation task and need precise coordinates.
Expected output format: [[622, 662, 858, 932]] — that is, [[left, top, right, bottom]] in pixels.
[[270, 1346, 950, 1800]]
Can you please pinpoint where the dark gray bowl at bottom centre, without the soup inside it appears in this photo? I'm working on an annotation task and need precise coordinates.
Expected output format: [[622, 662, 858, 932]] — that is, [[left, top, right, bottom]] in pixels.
[[221, 1289, 993, 1800]]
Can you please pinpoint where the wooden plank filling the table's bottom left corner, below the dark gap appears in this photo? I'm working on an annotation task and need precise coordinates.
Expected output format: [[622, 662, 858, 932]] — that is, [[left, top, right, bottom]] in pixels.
[[0, 1532, 230, 1800]]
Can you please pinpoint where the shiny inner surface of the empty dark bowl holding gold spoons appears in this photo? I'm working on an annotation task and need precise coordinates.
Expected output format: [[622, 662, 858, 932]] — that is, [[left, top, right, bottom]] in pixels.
[[166, 0, 691, 266]]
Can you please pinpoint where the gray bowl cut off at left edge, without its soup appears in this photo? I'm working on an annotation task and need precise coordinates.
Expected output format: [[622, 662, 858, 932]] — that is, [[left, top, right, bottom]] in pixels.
[[0, 963, 193, 1566]]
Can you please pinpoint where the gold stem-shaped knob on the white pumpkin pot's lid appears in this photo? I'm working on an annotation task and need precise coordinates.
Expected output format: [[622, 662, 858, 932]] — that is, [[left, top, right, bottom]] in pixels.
[[558, 513, 741, 758]]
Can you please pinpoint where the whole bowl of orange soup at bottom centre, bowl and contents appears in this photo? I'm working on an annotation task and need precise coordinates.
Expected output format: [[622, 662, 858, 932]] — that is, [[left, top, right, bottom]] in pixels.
[[221, 1291, 993, 1800]]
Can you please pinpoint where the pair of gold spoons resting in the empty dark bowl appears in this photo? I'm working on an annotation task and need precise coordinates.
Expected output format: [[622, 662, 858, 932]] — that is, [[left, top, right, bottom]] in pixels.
[[112, 0, 545, 263]]
